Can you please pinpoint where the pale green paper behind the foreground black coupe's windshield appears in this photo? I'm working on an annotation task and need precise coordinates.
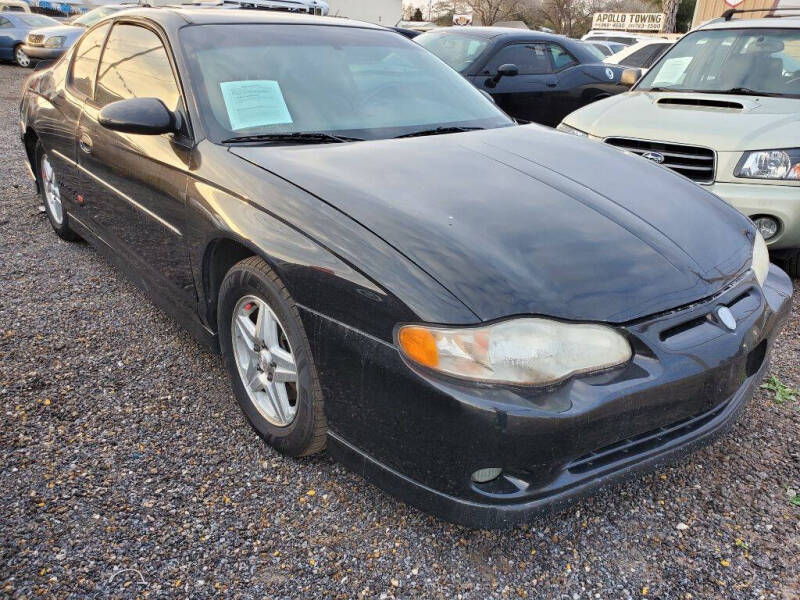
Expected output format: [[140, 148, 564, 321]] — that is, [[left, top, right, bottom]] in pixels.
[[219, 79, 292, 131]]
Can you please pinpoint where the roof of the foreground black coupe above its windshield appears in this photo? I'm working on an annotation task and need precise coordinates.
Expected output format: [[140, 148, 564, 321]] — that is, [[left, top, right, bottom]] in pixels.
[[112, 6, 385, 29]]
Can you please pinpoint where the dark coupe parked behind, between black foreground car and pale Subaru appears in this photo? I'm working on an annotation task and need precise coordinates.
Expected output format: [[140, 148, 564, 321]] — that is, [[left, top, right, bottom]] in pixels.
[[414, 27, 630, 127]]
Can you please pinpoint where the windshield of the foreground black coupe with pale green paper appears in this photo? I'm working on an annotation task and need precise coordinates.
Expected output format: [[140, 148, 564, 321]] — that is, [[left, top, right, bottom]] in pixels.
[[181, 24, 513, 142]]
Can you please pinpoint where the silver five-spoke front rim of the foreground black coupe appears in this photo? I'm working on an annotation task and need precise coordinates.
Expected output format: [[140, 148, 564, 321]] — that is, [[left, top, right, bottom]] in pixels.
[[231, 296, 297, 427]]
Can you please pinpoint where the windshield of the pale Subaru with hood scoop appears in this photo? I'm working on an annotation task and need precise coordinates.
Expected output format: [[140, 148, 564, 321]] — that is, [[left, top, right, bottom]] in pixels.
[[636, 29, 800, 97]]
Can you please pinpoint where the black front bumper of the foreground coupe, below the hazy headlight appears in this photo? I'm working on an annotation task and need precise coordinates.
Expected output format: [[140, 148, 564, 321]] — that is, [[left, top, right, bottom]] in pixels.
[[301, 265, 792, 528]]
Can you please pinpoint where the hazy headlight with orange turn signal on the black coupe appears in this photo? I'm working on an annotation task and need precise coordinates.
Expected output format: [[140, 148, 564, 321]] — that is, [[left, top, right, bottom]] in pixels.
[[397, 317, 631, 385]]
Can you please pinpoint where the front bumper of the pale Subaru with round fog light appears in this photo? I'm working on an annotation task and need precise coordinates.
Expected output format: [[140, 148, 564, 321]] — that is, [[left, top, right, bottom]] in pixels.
[[704, 182, 800, 250]]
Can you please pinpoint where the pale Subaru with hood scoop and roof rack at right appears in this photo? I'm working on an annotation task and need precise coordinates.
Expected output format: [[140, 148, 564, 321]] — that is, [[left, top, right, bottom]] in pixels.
[[559, 11, 800, 276]]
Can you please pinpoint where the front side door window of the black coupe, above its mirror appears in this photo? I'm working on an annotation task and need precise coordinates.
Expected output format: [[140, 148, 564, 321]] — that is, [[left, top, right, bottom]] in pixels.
[[95, 24, 180, 111]]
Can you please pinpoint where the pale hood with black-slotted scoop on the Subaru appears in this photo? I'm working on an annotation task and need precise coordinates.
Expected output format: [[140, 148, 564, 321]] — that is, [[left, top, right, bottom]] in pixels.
[[564, 91, 800, 152]]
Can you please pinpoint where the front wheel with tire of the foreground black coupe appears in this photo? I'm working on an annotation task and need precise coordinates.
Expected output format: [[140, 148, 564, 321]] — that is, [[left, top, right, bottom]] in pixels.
[[217, 256, 327, 456]]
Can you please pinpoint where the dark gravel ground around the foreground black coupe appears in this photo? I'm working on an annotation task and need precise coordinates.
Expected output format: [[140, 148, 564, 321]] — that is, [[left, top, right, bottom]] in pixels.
[[0, 66, 800, 599]]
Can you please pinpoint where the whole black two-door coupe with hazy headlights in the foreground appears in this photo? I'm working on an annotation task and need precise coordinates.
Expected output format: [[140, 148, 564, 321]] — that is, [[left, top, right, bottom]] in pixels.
[[20, 9, 791, 527]]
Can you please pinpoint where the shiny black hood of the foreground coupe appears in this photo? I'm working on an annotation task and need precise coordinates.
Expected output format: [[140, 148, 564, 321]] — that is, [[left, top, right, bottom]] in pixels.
[[231, 125, 753, 323]]
